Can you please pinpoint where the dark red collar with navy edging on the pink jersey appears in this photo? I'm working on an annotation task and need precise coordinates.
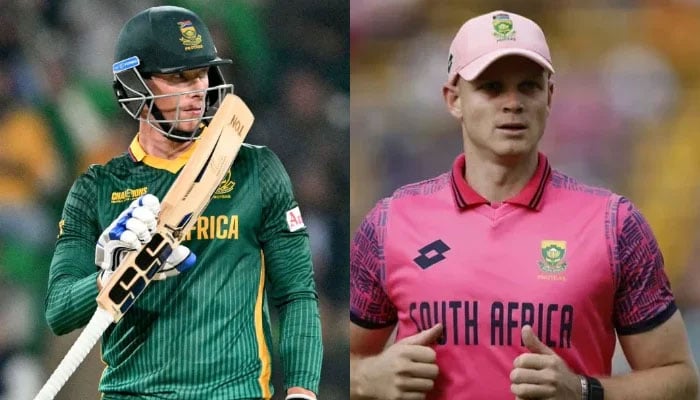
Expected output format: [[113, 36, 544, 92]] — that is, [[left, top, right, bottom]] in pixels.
[[450, 153, 552, 210]]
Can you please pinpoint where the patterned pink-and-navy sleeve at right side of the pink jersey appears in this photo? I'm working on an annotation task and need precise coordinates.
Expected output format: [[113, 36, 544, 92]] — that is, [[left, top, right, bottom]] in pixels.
[[611, 197, 676, 335]]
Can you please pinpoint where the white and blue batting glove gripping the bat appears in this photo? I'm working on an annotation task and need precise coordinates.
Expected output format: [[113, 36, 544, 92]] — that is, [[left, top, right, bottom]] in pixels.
[[95, 194, 196, 286]]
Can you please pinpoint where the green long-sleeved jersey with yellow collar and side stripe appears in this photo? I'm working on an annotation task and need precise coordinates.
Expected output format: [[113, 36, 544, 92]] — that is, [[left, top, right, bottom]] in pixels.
[[46, 138, 322, 400]]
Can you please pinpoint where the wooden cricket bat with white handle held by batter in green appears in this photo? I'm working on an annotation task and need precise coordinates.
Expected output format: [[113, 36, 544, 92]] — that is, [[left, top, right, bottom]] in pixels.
[[34, 94, 254, 400]]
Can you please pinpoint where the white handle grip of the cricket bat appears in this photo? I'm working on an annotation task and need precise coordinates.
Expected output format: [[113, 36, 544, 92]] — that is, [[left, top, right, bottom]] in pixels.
[[34, 307, 113, 400]]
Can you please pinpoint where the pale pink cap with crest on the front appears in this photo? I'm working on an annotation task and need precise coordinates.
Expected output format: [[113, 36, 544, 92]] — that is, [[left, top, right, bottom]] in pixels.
[[447, 10, 554, 84]]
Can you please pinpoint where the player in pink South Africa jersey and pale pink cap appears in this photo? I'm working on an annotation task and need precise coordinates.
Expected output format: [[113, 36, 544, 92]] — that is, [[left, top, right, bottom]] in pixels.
[[350, 11, 698, 400]]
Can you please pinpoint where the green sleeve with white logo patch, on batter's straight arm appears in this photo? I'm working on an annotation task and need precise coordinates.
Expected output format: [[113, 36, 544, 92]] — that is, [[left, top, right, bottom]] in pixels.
[[259, 147, 323, 393]]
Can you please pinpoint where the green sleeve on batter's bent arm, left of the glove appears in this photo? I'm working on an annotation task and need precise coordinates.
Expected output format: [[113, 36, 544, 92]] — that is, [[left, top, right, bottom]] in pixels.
[[45, 167, 99, 335]]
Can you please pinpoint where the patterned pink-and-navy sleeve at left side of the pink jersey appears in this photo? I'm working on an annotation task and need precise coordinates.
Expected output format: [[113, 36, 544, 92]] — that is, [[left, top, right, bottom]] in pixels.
[[350, 199, 398, 329]]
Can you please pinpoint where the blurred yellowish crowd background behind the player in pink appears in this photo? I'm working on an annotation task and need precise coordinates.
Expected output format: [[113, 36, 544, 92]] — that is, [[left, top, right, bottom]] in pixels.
[[350, 0, 700, 371]]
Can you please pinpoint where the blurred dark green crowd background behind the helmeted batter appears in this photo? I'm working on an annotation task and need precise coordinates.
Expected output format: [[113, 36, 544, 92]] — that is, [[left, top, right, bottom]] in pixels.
[[0, 0, 350, 400]]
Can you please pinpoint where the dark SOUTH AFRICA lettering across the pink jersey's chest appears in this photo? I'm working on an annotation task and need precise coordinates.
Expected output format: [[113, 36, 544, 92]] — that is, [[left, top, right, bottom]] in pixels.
[[408, 300, 574, 348]]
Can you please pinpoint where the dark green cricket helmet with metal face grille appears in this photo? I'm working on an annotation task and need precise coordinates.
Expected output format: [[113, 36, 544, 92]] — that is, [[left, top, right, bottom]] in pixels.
[[112, 6, 233, 141]]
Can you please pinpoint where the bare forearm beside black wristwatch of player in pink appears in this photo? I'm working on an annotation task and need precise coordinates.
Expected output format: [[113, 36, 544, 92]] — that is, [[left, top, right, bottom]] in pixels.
[[599, 363, 698, 400]]
